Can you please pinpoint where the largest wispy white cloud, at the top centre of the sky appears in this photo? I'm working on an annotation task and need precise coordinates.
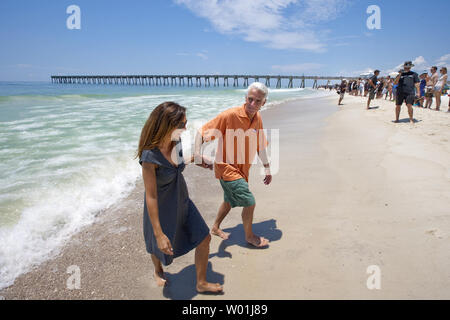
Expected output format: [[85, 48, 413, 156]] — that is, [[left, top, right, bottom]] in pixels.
[[174, 0, 347, 52]]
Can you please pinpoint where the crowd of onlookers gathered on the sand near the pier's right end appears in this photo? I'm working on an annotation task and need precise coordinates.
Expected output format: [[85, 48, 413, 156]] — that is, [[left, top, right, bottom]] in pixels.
[[332, 61, 450, 122]]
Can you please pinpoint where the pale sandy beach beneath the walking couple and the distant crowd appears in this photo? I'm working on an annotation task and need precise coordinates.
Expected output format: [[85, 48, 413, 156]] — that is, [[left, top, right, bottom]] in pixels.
[[0, 95, 450, 300]]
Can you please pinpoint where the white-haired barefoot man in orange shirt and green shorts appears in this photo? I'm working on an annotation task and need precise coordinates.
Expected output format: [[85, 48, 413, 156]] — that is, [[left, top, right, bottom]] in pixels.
[[195, 82, 272, 247]]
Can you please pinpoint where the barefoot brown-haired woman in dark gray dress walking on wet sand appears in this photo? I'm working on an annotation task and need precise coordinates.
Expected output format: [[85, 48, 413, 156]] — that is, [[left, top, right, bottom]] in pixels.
[[137, 102, 222, 292]]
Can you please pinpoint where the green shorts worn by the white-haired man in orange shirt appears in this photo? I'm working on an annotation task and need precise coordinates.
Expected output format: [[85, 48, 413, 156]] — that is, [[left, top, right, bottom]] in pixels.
[[219, 178, 256, 208]]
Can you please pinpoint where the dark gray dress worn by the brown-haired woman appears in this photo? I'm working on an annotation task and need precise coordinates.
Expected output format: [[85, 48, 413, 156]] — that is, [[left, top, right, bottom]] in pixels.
[[139, 140, 209, 266]]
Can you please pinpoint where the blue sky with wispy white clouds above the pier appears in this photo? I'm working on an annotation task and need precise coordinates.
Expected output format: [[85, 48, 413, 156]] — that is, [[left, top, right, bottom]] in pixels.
[[0, 0, 450, 81]]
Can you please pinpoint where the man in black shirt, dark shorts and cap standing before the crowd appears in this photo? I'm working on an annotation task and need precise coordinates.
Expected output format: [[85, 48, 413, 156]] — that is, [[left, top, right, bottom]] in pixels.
[[394, 61, 420, 123]]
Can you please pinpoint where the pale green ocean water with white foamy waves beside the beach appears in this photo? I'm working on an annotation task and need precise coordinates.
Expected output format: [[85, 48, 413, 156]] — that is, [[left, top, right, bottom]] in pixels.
[[0, 82, 329, 289]]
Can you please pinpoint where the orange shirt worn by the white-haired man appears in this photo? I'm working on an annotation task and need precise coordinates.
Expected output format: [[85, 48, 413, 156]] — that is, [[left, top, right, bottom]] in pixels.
[[201, 104, 268, 181]]
